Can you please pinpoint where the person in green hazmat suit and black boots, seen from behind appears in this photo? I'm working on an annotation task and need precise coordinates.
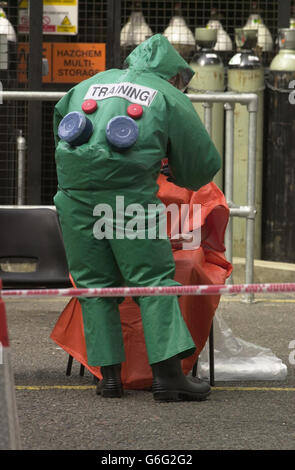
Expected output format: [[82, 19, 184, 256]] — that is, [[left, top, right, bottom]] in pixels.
[[54, 34, 221, 401]]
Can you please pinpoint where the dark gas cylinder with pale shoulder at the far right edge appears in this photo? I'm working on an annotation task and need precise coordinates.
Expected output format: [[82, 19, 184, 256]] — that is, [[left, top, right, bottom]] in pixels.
[[262, 28, 295, 263]]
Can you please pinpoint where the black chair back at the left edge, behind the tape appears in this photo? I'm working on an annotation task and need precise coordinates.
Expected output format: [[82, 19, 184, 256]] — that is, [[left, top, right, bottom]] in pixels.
[[0, 207, 84, 375]]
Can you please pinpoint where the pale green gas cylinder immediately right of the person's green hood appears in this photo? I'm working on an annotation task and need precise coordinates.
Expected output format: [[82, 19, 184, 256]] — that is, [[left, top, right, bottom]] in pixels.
[[188, 28, 224, 190]]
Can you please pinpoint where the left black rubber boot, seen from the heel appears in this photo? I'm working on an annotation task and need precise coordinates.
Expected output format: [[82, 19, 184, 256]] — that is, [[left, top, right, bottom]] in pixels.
[[96, 364, 123, 398]]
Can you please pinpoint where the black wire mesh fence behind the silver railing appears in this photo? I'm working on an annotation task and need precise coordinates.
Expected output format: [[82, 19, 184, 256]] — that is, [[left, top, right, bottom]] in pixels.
[[0, 0, 294, 204]]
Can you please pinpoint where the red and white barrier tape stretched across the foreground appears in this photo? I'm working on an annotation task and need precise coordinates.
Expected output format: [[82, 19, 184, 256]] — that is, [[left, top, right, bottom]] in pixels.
[[0, 283, 295, 297]]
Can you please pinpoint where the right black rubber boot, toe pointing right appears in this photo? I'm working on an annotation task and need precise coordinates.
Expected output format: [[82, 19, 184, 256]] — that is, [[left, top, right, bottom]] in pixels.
[[151, 356, 211, 401]]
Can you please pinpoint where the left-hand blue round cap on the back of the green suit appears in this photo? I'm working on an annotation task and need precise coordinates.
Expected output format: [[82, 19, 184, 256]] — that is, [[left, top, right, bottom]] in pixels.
[[58, 111, 93, 147]]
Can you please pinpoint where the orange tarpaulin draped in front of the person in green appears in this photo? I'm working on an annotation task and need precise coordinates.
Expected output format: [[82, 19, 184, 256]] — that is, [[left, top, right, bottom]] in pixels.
[[50, 175, 232, 389]]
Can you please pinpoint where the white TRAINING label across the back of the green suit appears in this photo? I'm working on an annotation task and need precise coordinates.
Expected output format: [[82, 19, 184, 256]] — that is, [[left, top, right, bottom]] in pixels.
[[84, 82, 158, 107]]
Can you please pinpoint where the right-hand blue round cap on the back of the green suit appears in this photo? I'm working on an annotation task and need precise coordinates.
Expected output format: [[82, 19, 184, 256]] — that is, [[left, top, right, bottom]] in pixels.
[[106, 116, 138, 149]]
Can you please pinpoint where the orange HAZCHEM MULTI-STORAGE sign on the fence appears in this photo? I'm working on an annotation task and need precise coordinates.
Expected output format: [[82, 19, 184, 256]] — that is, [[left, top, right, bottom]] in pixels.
[[18, 42, 106, 83]]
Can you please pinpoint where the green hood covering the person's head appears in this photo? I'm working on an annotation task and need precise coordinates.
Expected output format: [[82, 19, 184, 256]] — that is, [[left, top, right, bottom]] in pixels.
[[126, 34, 195, 83]]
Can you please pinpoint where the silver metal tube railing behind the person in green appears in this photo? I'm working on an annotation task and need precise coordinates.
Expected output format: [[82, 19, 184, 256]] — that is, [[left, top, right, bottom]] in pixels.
[[0, 91, 258, 303]]
